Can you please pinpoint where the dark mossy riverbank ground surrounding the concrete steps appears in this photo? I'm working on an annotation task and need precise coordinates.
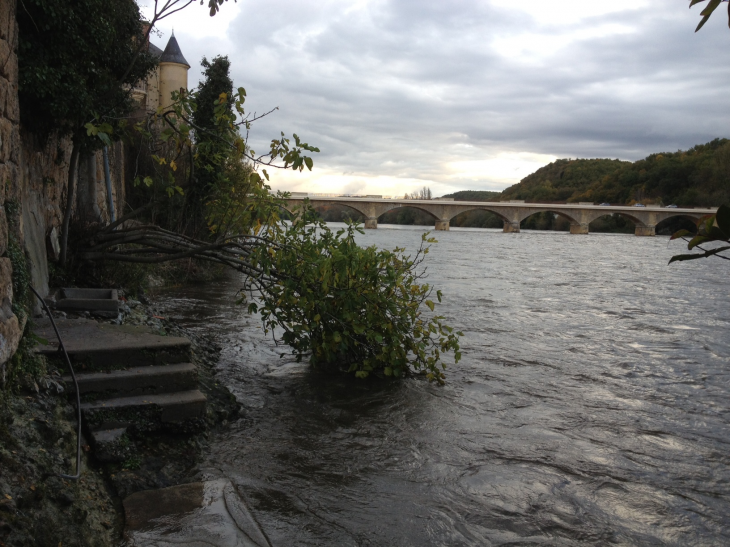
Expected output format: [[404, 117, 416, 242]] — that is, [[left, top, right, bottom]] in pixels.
[[0, 300, 238, 547]]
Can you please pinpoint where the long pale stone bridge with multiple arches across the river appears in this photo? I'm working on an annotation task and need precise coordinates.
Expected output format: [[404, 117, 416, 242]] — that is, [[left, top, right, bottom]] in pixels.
[[288, 199, 717, 236]]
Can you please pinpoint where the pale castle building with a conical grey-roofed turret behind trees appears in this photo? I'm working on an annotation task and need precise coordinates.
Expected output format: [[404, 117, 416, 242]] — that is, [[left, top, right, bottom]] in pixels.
[[132, 32, 190, 112]]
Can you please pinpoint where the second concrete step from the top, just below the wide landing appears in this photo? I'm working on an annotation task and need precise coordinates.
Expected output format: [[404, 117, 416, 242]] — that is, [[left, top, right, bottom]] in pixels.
[[63, 363, 198, 398]]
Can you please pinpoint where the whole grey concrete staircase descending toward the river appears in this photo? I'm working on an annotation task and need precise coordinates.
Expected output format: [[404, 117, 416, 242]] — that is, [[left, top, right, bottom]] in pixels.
[[34, 319, 206, 461]]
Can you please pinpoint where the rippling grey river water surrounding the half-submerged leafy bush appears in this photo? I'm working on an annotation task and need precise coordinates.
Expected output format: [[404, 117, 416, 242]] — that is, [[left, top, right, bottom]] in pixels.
[[154, 226, 730, 546]]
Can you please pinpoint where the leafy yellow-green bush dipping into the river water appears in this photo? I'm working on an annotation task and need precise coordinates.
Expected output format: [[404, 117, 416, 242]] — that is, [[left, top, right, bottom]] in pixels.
[[249, 210, 463, 383]]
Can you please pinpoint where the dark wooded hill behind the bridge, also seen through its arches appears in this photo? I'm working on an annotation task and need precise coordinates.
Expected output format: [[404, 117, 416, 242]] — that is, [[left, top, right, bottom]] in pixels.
[[320, 139, 730, 233]]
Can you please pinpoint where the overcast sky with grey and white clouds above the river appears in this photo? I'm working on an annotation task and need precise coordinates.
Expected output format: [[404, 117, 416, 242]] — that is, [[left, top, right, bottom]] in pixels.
[[140, 0, 730, 195]]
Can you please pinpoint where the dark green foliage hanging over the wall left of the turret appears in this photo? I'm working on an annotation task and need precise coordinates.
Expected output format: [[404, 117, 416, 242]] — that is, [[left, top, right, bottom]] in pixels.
[[17, 0, 157, 149]]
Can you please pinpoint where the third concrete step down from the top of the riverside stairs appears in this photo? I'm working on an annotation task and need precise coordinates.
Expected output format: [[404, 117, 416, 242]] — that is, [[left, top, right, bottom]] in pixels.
[[81, 389, 207, 432]]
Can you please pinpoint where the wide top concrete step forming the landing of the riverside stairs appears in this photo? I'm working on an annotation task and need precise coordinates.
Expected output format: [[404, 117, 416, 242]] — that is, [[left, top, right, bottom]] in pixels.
[[33, 318, 192, 372]]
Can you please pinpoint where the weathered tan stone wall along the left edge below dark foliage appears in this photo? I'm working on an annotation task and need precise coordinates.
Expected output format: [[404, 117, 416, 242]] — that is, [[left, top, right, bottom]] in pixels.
[[0, 0, 125, 376]]
